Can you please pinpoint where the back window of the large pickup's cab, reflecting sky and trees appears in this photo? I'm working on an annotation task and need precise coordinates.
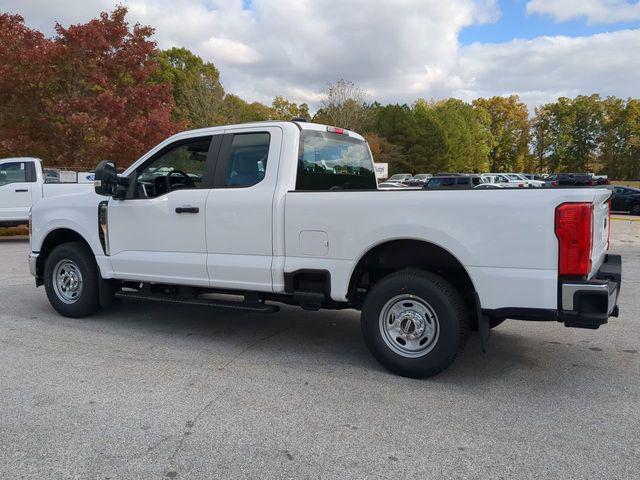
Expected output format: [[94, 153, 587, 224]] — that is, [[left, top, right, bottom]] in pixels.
[[296, 130, 378, 190]]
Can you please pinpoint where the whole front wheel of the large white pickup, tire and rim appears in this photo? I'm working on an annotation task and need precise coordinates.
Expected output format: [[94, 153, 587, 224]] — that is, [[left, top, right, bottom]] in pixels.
[[44, 242, 100, 318]]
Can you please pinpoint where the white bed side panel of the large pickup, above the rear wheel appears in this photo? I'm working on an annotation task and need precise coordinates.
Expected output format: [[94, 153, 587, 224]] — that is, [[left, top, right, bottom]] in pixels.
[[285, 189, 594, 309]]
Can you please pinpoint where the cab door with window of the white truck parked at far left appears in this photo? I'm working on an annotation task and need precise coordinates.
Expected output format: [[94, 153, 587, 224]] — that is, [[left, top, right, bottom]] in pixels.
[[0, 160, 35, 221]]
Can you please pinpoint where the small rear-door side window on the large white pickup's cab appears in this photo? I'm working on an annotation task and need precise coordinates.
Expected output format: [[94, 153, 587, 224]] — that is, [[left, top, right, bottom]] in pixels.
[[216, 132, 271, 187]]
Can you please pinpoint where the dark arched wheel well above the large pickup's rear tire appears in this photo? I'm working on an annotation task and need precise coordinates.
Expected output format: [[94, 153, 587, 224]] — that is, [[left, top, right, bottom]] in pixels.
[[347, 240, 476, 316]]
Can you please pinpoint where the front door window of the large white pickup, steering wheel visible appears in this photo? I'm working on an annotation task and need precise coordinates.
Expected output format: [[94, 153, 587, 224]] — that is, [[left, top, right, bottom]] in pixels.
[[135, 136, 212, 198]]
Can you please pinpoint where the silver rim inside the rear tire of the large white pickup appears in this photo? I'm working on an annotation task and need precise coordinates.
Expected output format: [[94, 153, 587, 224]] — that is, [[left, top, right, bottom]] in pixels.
[[379, 294, 440, 358]]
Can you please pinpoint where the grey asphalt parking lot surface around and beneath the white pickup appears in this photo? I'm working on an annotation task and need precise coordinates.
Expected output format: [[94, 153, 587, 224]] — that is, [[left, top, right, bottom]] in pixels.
[[0, 217, 640, 479]]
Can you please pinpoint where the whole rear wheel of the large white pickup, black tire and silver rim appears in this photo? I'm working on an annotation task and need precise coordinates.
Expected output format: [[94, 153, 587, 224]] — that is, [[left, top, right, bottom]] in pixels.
[[361, 270, 469, 378]]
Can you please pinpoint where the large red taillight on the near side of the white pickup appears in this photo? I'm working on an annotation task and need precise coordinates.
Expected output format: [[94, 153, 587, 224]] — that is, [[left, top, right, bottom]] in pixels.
[[556, 203, 593, 276]]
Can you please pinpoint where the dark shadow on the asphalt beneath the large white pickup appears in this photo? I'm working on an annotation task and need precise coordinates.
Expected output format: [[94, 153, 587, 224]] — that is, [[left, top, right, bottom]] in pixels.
[[28, 294, 604, 386]]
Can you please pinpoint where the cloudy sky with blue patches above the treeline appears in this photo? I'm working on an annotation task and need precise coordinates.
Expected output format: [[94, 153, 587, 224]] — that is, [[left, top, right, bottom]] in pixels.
[[5, 0, 640, 106]]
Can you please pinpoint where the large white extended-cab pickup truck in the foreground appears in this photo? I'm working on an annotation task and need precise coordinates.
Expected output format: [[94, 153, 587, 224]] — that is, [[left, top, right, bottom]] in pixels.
[[29, 121, 621, 377]]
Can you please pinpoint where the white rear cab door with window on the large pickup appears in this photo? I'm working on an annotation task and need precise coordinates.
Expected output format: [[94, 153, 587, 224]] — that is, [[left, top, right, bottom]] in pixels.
[[206, 126, 282, 291]]
